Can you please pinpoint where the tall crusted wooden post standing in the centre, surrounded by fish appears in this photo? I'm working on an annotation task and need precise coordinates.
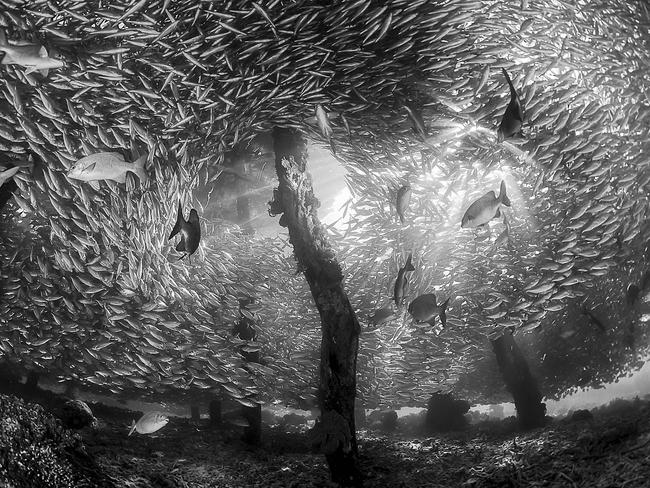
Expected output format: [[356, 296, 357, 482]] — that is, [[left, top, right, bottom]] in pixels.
[[269, 127, 362, 486]]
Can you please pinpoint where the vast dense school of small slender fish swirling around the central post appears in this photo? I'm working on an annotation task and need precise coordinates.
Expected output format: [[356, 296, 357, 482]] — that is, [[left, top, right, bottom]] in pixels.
[[0, 0, 650, 406]]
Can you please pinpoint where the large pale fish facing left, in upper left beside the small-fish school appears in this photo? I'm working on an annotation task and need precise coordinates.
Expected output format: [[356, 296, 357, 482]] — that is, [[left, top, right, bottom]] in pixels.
[[68, 152, 148, 190]]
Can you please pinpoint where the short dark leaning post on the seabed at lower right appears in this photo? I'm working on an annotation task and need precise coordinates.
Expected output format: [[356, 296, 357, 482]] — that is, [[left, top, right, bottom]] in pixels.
[[492, 332, 546, 429]]
